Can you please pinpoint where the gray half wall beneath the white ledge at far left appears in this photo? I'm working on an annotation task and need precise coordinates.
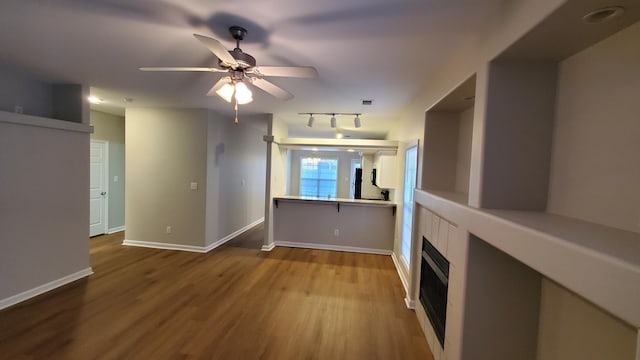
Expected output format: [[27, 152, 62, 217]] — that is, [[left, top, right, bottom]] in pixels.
[[0, 113, 89, 301]]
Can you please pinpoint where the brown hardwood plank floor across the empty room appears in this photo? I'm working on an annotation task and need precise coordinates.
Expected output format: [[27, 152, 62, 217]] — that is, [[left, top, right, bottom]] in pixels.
[[0, 228, 433, 359]]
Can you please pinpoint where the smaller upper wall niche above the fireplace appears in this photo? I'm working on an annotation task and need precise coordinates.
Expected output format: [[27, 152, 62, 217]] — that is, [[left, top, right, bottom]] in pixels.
[[422, 74, 476, 204]]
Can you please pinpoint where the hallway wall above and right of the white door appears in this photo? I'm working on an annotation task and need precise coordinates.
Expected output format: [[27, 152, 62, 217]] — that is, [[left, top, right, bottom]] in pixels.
[[90, 111, 125, 231]]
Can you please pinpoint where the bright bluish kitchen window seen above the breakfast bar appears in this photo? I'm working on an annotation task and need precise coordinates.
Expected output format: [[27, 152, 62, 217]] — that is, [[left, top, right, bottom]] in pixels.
[[300, 157, 338, 197]]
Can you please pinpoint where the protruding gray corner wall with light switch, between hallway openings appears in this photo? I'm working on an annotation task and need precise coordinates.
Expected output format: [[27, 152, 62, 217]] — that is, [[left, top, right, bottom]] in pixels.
[[125, 109, 267, 247]]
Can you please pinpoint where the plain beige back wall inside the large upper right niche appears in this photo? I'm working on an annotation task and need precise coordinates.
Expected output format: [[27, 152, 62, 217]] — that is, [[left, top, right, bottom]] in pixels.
[[547, 23, 640, 233]]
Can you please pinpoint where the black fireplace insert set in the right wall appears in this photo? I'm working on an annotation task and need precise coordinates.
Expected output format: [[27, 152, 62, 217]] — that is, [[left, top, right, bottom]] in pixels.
[[420, 236, 449, 347]]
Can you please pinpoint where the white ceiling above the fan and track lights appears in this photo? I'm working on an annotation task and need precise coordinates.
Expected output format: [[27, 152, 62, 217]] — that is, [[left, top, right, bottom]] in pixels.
[[0, 0, 504, 138]]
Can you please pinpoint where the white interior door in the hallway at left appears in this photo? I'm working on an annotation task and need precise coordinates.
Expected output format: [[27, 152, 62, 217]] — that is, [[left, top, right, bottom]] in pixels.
[[89, 140, 108, 236]]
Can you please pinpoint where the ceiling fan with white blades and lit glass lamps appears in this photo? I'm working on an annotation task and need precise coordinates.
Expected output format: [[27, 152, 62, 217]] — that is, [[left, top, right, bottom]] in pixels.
[[140, 26, 318, 104]]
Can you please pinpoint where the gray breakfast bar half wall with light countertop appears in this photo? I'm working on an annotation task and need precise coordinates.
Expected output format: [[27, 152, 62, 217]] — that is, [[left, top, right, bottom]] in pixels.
[[273, 195, 396, 255]]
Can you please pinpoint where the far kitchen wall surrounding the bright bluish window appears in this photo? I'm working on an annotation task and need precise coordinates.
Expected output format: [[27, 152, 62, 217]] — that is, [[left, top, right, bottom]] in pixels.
[[289, 150, 368, 198]]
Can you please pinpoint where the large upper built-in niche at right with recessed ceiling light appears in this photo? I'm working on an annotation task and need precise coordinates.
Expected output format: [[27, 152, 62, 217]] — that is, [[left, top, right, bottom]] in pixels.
[[478, 1, 640, 233]]
